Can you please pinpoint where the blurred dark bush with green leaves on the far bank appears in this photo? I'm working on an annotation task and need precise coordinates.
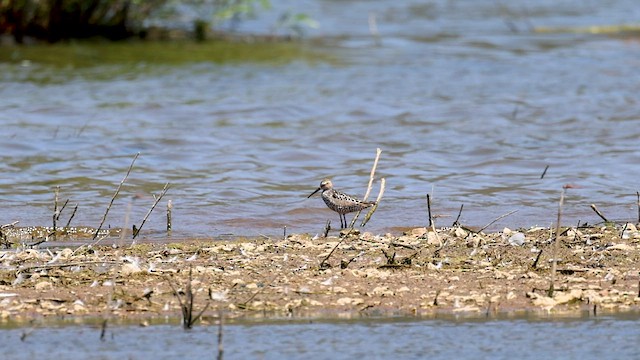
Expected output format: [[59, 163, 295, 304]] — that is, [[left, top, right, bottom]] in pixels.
[[0, 0, 317, 43]]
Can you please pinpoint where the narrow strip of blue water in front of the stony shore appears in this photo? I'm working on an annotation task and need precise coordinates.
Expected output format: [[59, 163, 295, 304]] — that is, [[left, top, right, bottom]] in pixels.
[[0, 317, 640, 360]]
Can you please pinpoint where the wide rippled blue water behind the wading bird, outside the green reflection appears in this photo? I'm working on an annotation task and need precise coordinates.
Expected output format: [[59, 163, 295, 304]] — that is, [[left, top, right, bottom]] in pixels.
[[0, 0, 640, 237]]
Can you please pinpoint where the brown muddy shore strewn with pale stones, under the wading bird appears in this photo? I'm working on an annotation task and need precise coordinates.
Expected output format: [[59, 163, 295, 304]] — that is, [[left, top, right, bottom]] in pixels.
[[0, 224, 640, 322]]
